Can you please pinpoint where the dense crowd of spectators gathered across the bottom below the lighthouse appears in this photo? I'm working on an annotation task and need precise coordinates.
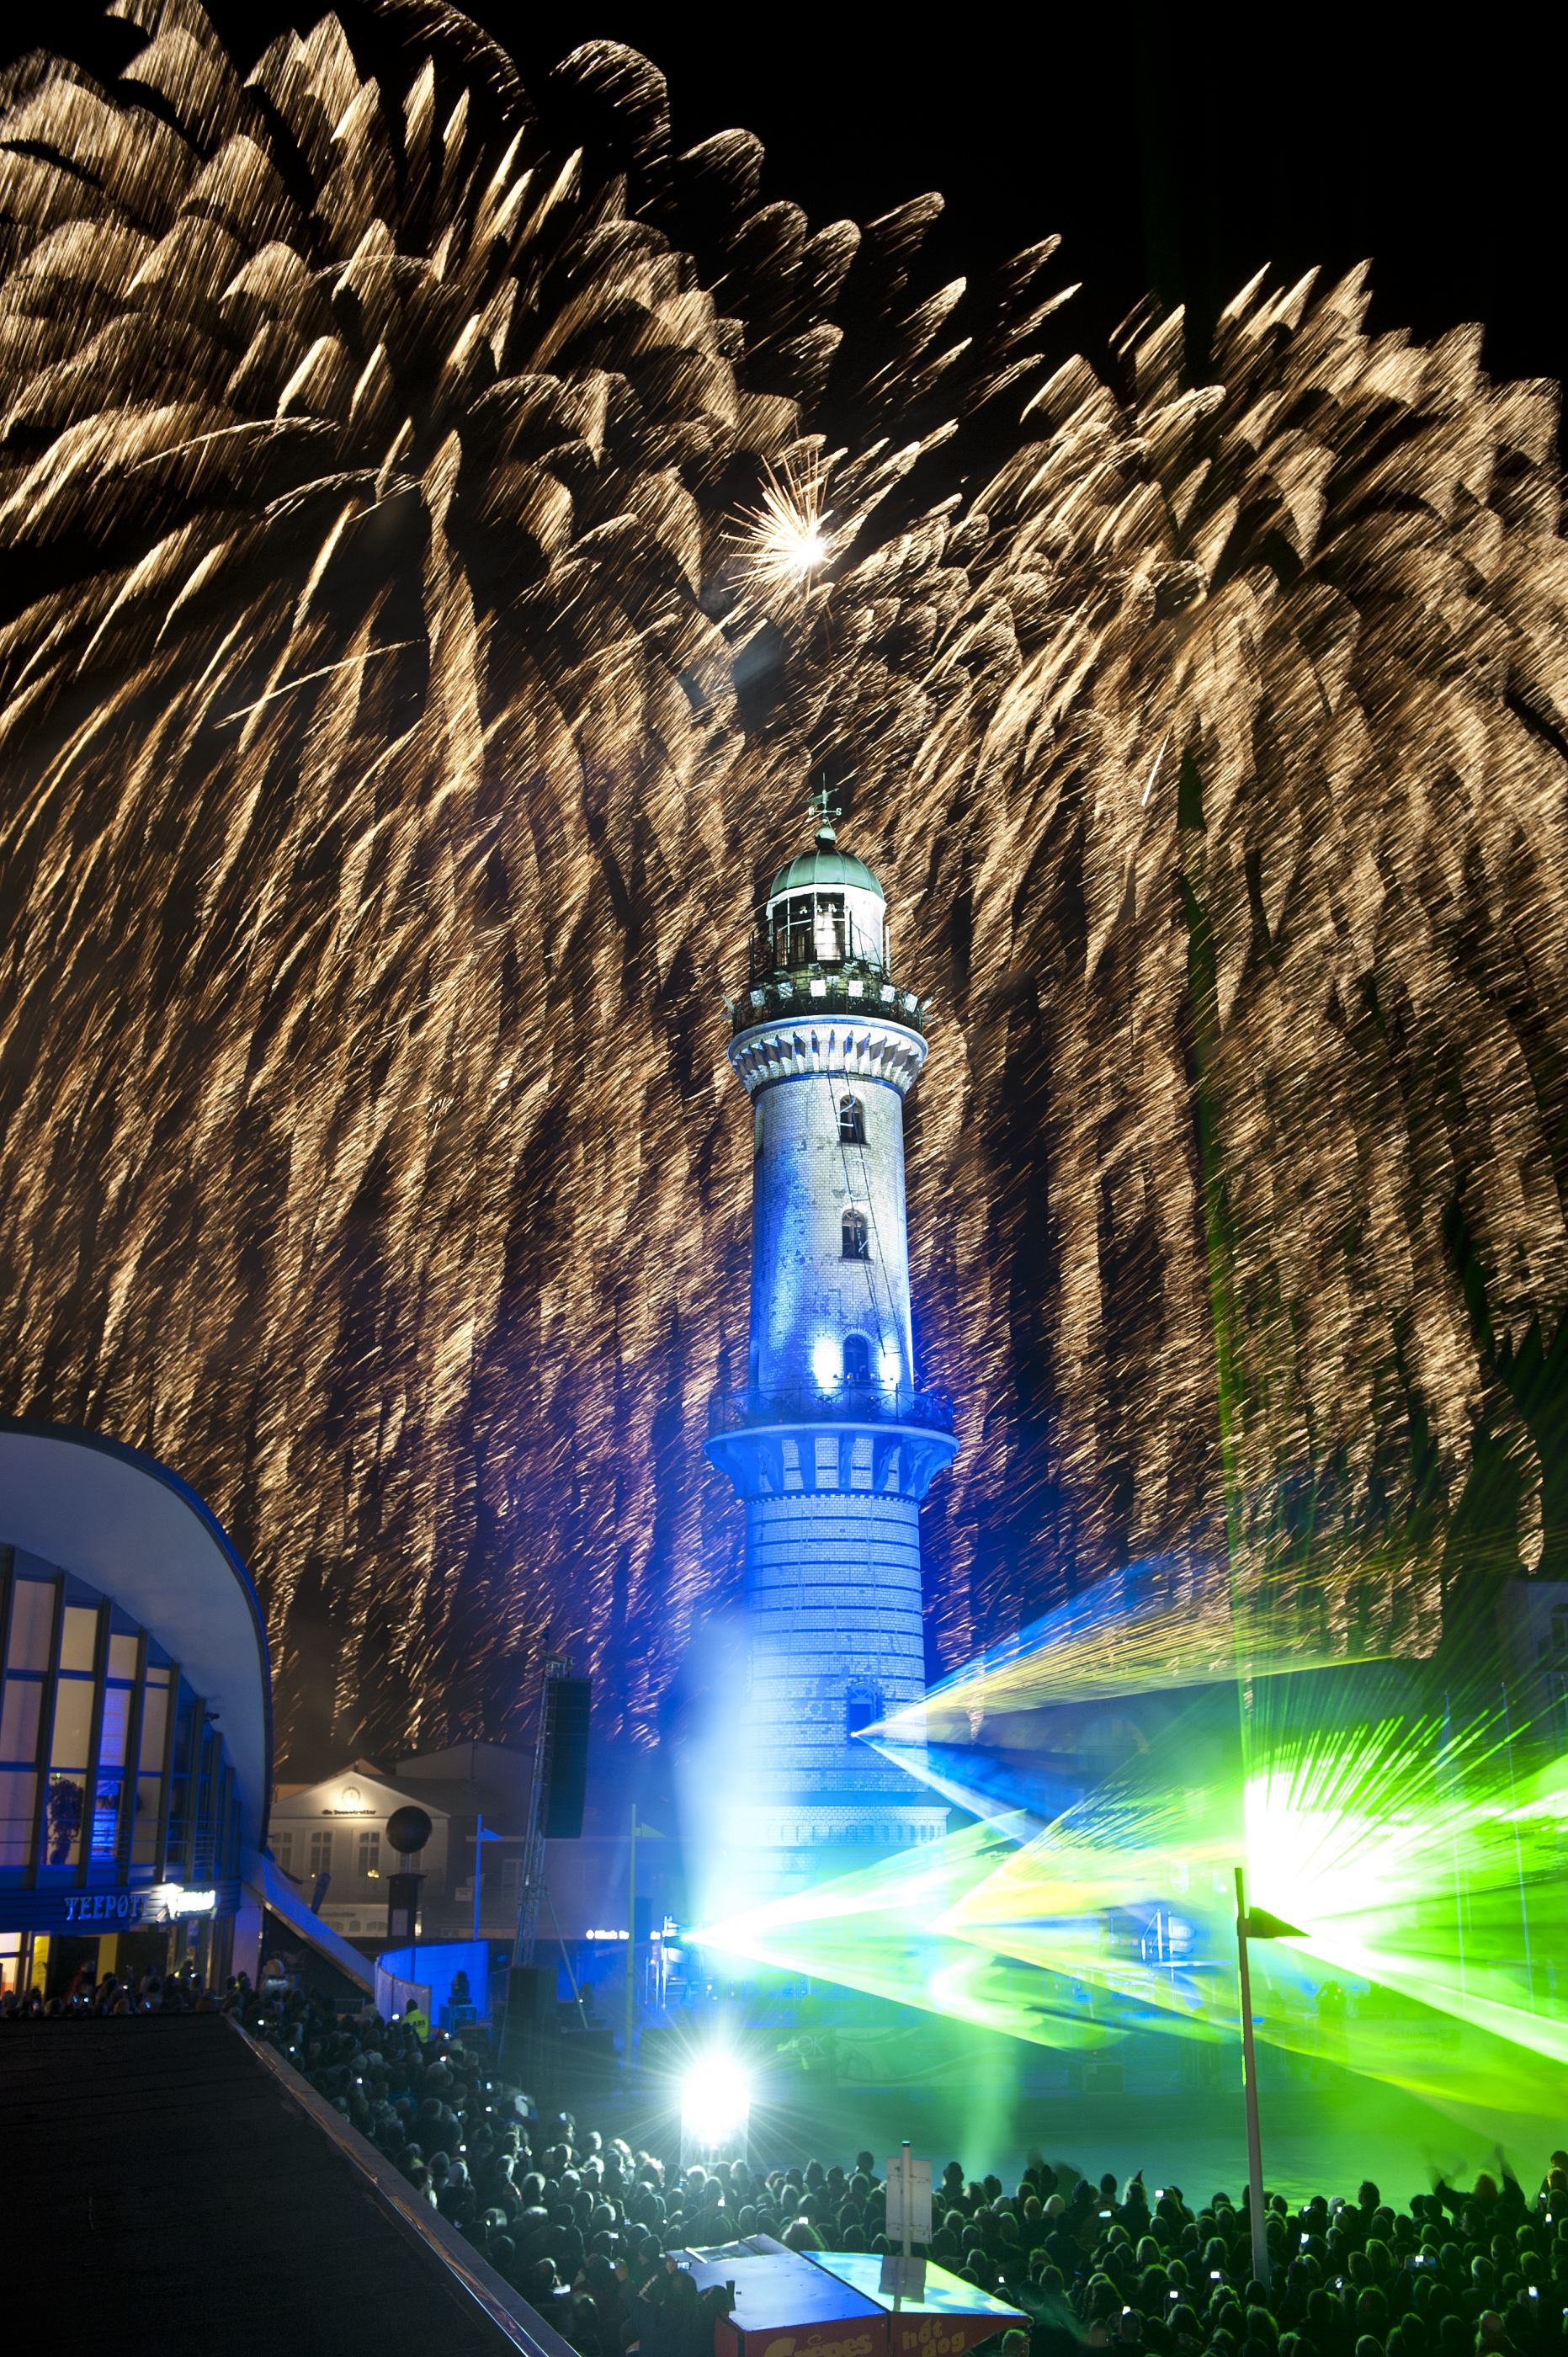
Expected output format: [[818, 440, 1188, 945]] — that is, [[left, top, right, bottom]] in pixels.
[[7, 1973, 1568, 2357]]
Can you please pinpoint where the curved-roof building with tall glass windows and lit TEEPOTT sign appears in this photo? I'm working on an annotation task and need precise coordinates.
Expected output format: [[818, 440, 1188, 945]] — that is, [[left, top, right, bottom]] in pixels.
[[0, 1423, 271, 1997]]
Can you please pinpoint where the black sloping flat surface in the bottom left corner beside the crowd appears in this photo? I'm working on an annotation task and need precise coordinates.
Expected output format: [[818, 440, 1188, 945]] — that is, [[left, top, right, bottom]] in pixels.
[[0, 2015, 556, 2357]]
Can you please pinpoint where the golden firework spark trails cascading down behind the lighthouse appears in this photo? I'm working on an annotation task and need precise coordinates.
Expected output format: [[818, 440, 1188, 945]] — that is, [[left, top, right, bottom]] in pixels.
[[0, 0, 1568, 1751]]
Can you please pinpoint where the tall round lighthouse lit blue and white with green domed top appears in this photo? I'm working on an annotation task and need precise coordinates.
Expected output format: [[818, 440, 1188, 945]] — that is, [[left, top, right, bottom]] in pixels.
[[707, 796, 957, 1900]]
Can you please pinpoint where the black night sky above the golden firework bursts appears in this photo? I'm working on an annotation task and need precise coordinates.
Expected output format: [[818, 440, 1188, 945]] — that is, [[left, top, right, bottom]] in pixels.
[[12, 0, 1568, 405]]
